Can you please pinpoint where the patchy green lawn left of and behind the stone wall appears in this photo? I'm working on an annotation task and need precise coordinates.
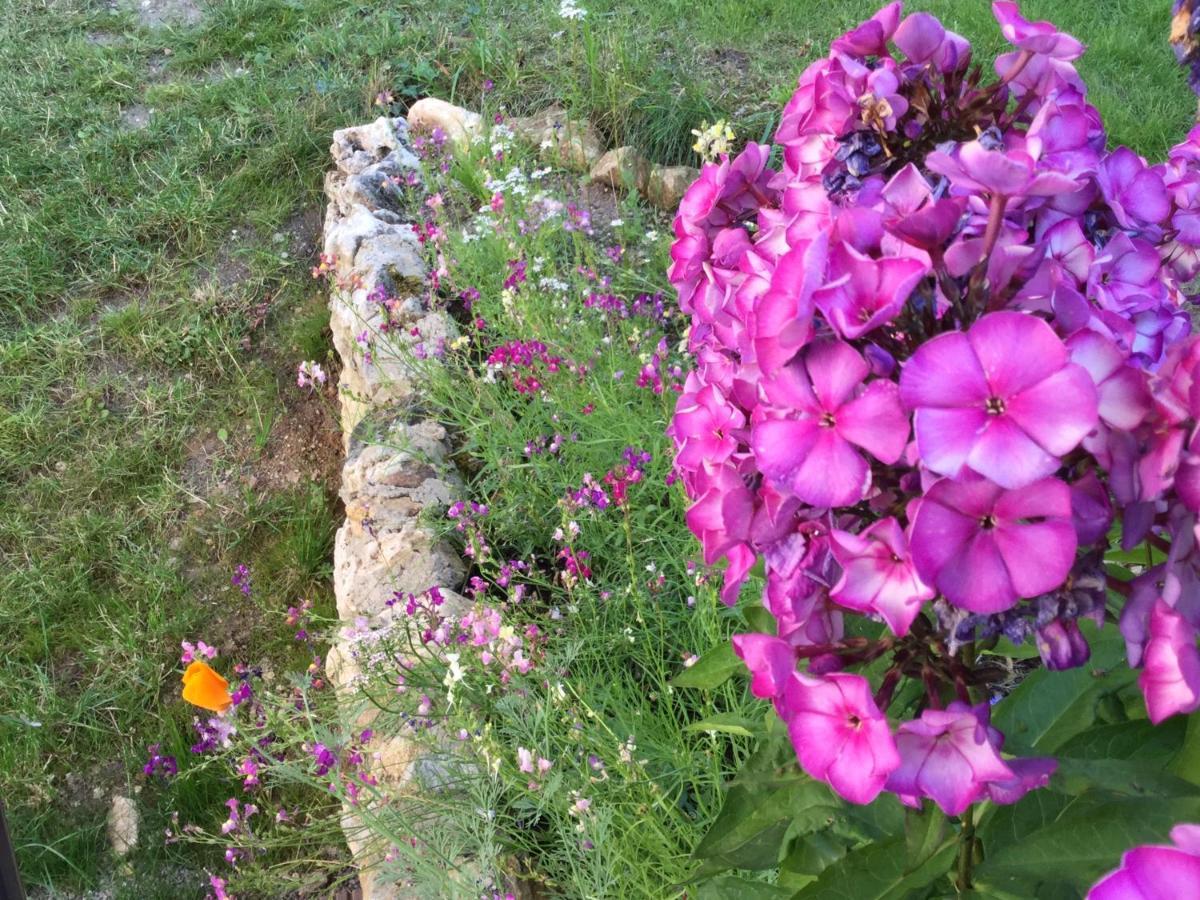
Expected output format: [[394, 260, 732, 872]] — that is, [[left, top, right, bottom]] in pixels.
[[0, 0, 1195, 898]]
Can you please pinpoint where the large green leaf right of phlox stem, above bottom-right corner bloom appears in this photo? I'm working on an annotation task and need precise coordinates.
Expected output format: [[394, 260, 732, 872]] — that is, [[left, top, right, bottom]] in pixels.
[[974, 791, 1200, 896]]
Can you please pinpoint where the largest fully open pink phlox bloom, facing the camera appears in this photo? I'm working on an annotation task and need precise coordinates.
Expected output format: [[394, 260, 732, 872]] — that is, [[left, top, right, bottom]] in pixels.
[[900, 312, 1097, 488]]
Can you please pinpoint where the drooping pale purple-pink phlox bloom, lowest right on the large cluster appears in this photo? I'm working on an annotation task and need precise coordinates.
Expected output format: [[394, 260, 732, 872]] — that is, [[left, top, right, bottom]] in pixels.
[[887, 702, 1018, 816]]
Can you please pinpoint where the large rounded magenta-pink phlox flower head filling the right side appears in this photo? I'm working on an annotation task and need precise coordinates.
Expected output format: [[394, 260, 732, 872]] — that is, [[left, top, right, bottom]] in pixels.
[[670, 0, 1200, 814]]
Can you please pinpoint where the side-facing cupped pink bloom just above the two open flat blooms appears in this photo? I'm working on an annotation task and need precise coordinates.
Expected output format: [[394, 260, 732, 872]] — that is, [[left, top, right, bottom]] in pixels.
[[812, 244, 928, 341]]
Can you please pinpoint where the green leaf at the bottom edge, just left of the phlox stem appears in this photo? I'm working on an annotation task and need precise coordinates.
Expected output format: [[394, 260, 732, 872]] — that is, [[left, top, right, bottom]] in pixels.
[[796, 838, 955, 900]]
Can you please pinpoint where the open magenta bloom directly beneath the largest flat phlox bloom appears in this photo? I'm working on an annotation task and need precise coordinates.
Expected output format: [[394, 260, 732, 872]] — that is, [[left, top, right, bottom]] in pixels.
[[910, 478, 1076, 613]]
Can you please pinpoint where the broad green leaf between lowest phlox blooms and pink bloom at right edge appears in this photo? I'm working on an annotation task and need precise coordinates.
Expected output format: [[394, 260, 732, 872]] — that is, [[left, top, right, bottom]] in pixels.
[[992, 620, 1136, 752]]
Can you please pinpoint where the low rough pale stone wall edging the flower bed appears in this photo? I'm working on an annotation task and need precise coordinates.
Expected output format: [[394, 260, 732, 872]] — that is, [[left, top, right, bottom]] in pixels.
[[324, 114, 463, 900]]
